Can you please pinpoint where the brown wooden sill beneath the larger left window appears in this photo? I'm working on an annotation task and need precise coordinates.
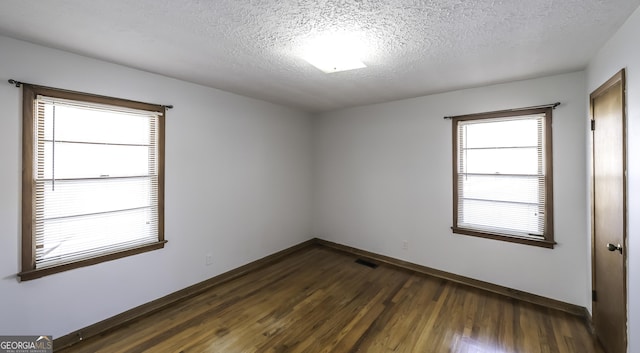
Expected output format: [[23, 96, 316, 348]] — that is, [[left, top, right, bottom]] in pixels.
[[18, 240, 167, 281]]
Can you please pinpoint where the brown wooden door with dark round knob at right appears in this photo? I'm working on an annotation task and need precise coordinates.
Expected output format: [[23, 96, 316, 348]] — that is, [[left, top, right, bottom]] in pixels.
[[590, 70, 627, 353]]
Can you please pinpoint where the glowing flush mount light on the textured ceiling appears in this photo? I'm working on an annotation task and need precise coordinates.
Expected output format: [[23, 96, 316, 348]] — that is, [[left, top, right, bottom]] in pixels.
[[303, 33, 367, 73]]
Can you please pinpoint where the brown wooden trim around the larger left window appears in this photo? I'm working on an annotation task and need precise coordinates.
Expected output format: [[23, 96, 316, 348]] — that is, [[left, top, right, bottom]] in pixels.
[[17, 84, 167, 281]]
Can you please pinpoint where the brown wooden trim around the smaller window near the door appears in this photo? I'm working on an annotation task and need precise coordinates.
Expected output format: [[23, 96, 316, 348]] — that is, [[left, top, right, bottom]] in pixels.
[[451, 106, 557, 249]]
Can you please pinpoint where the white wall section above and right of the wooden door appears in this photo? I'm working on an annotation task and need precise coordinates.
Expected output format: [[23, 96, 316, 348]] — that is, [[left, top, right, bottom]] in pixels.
[[587, 8, 640, 352]]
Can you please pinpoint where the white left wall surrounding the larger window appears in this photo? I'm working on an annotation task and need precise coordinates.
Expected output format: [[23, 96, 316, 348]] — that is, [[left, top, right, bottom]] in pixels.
[[0, 37, 311, 337]]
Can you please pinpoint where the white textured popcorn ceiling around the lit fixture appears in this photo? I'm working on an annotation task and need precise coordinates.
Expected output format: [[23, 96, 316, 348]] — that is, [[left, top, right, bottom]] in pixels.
[[0, 0, 640, 112]]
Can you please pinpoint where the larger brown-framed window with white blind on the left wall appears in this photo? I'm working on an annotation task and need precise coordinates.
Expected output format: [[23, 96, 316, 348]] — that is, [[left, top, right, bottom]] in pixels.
[[19, 85, 165, 280]]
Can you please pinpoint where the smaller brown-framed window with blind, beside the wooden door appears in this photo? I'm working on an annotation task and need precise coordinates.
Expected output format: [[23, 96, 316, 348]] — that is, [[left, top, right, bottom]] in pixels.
[[453, 107, 555, 248]]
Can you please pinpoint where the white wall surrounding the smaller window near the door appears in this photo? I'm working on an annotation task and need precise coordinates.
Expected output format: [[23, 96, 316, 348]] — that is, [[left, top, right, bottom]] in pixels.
[[313, 72, 589, 306]]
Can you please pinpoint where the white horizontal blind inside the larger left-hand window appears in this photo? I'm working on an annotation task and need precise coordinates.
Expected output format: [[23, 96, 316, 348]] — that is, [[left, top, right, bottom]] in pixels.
[[33, 95, 160, 268]]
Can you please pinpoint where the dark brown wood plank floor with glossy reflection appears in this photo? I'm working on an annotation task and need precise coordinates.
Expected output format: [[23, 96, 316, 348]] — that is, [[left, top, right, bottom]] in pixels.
[[55, 246, 602, 353]]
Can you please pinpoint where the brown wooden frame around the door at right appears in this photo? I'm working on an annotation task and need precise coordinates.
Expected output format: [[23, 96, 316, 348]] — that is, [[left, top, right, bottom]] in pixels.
[[589, 68, 629, 351]]
